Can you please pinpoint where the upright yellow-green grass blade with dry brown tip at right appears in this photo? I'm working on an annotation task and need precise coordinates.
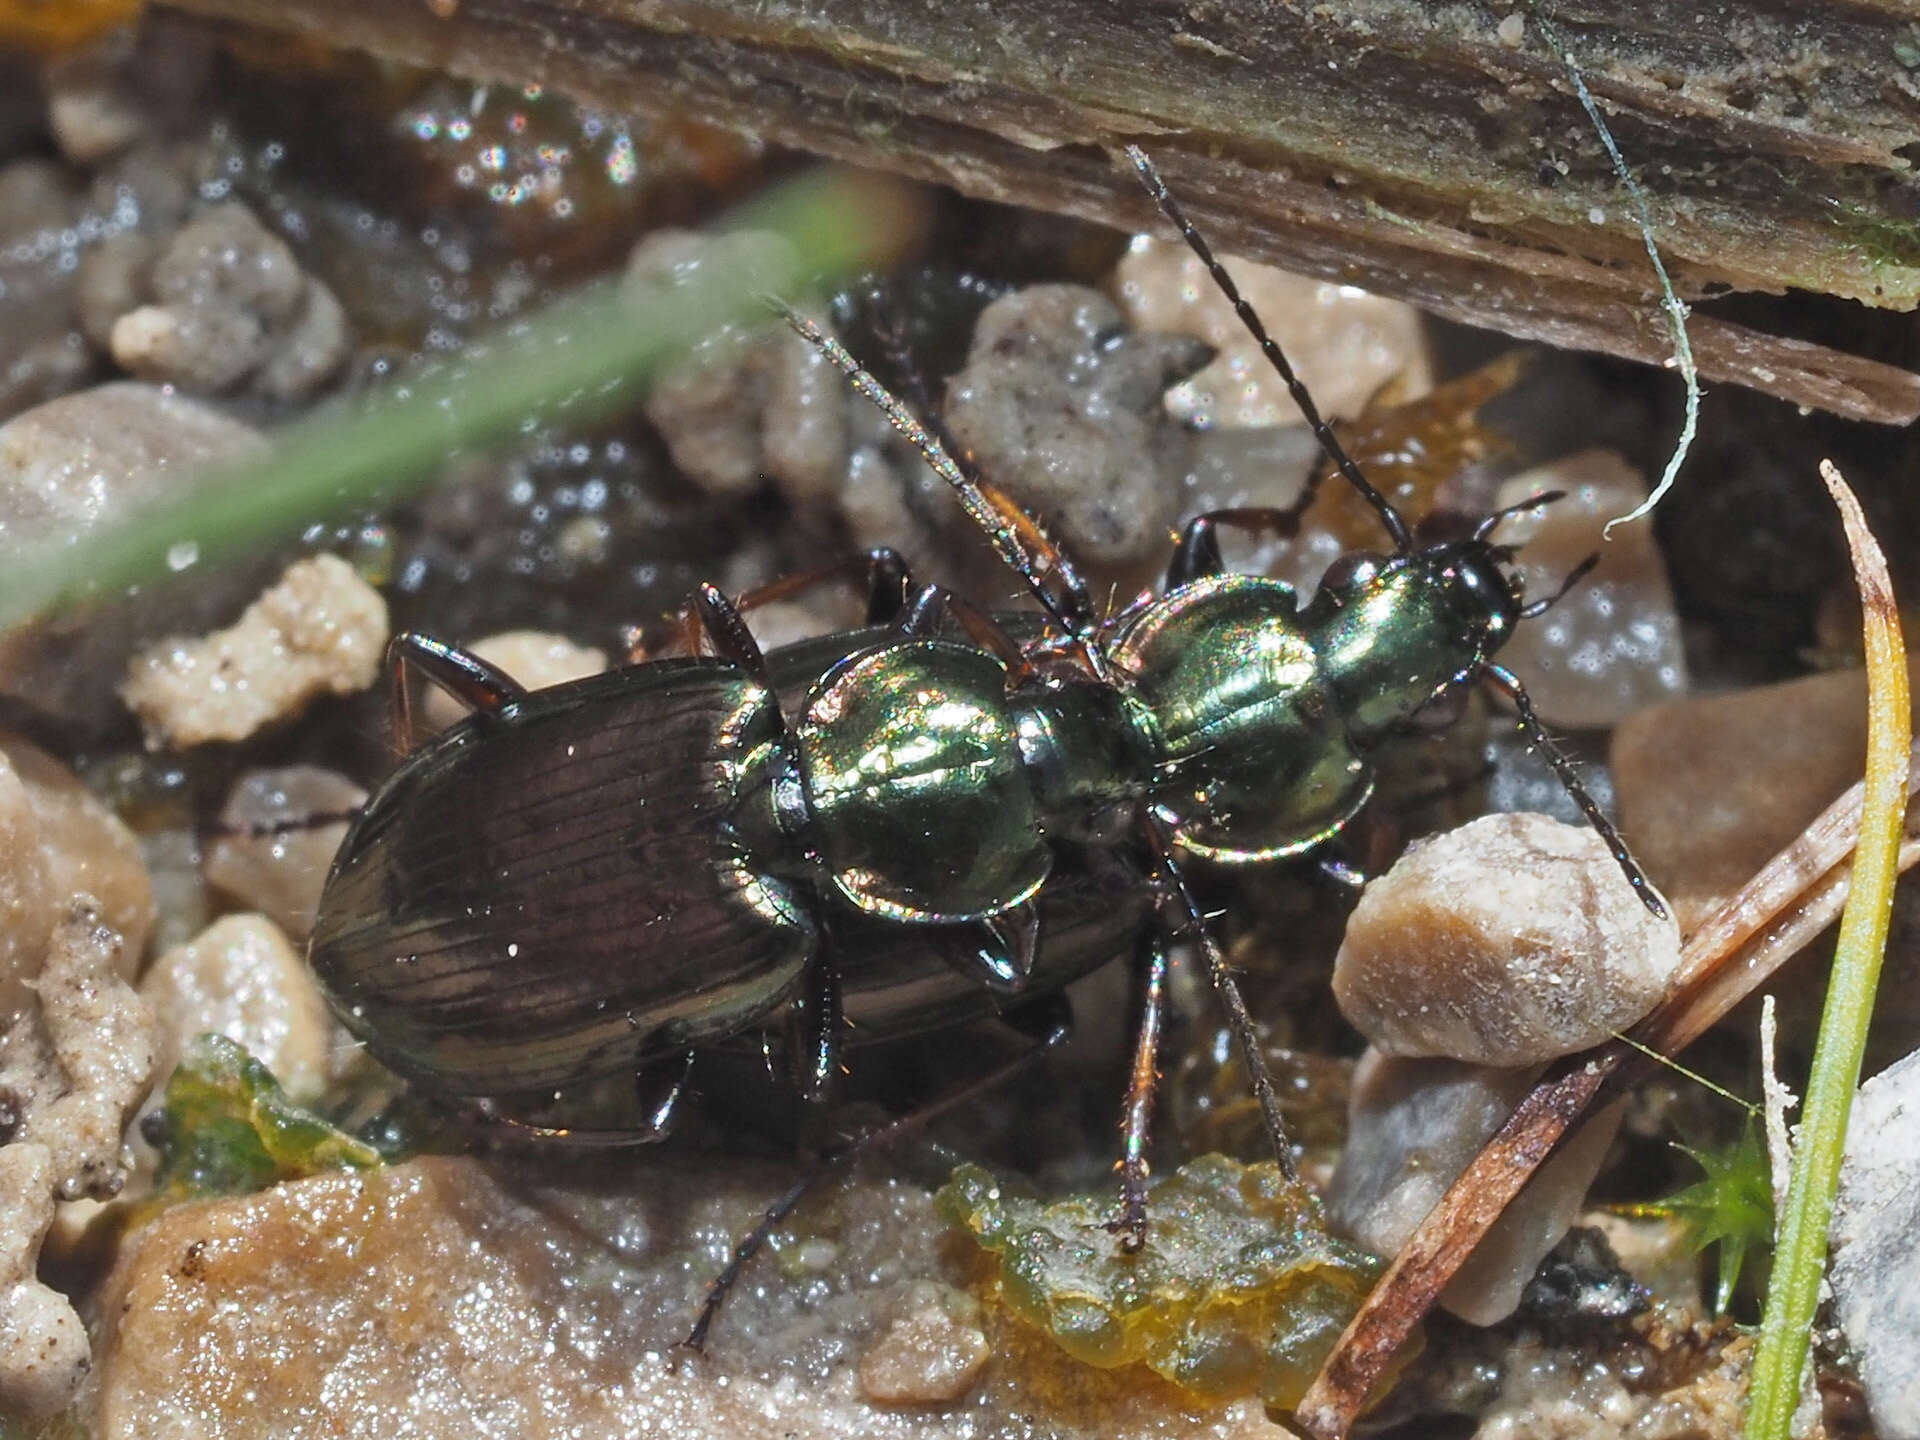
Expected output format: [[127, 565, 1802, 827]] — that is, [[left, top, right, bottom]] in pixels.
[[1747, 470, 1912, 1440]]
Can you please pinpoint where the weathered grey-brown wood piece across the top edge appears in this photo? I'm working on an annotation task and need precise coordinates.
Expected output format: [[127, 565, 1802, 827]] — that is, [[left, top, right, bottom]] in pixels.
[[161, 0, 1920, 422]]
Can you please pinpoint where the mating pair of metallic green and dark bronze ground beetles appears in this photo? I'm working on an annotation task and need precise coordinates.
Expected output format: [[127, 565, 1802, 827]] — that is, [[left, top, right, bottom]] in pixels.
[[311, 150, 1661, 1344]]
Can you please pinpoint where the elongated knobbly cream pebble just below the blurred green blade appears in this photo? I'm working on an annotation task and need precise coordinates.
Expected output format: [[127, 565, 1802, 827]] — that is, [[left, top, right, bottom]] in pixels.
[[121, 555, 388, 749]]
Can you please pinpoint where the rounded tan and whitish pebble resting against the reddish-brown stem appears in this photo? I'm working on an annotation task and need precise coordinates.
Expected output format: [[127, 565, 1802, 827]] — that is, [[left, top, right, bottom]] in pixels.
[[1332, 814, 1680, 1068]]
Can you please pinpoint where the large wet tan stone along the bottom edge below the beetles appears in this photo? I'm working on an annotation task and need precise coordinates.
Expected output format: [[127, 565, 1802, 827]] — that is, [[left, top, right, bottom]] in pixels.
[[93, 1152, 1284, 1440]]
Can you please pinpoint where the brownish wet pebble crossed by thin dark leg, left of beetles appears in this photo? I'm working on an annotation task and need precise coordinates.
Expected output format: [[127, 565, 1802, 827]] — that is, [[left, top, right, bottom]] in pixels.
[[205, 764, 367, 941]]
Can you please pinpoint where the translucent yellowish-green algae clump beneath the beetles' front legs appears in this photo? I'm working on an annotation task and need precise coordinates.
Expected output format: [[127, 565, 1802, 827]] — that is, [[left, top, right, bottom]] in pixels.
[[937, 1156, 1380, 1409]]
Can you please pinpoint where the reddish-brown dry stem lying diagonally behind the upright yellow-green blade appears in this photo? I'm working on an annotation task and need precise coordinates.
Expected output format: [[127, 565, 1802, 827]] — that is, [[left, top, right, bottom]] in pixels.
[[1294, 749, 1920, 1440]]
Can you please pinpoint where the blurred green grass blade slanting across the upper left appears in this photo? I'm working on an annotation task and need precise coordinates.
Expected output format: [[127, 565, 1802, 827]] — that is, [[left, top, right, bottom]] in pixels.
[[0, 173, 912, 630]]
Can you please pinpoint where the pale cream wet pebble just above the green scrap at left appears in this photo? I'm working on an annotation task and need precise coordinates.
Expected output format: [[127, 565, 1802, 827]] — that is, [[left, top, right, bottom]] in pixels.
[[140, 916, 334, 1104]]
